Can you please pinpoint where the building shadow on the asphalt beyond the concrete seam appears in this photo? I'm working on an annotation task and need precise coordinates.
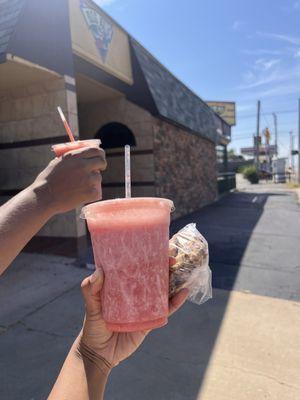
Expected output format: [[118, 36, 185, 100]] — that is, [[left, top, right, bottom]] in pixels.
[[171, 192, 286, 290]]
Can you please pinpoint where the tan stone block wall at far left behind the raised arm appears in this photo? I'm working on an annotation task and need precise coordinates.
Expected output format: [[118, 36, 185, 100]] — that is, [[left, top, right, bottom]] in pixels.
[[0, 77, 85, 238]]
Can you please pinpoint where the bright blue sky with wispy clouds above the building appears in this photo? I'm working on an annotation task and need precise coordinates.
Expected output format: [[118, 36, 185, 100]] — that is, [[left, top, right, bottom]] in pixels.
[[96, 0, 300, 156]]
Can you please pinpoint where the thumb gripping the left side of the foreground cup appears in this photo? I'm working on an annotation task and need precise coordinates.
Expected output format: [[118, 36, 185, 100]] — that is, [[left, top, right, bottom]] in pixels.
[[81, 268, 104, 316]]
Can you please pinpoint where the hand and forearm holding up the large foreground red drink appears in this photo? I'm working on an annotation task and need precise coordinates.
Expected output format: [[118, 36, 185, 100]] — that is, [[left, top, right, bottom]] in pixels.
[[48, 269, 188, 400]]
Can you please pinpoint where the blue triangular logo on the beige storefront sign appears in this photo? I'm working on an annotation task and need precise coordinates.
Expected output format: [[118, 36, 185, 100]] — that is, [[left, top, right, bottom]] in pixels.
[[80, 0, 113, 62]]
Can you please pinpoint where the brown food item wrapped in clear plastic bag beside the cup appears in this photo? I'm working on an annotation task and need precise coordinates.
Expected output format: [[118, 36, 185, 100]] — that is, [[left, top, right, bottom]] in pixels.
[[169, 224, 212, 304]]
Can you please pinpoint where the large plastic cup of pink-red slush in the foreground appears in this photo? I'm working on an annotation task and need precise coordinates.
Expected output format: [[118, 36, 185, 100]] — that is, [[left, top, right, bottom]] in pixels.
[[82, 197, 173, 332]]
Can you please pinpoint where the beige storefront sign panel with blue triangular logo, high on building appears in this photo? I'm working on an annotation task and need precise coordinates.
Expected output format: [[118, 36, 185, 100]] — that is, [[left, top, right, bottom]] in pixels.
[[69, 0, 133, 84]]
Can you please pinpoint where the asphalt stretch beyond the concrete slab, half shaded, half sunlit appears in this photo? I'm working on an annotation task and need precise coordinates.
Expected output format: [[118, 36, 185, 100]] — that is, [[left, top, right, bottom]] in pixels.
[[172, 184, 300, 301]]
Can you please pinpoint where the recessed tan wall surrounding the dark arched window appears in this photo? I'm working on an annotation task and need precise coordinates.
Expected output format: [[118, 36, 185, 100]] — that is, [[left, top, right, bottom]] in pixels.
[[79, 97, 155, 199]]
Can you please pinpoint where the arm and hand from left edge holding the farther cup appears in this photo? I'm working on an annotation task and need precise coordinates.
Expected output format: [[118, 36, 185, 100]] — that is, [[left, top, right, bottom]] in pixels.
[[0, 148, 106, 275]]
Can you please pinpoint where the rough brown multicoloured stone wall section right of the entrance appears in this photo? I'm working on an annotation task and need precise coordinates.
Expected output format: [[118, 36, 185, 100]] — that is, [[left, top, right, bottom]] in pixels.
[[154, 120, 217, 218]]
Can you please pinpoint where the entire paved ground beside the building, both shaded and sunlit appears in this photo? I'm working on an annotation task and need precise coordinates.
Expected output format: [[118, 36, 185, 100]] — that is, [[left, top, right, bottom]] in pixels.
[[0, 185, 300, 400]]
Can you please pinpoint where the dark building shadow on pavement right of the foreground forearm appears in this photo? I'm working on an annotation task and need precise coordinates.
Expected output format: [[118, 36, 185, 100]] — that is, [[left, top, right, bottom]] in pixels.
[[107, 192, 292, 400]]
